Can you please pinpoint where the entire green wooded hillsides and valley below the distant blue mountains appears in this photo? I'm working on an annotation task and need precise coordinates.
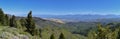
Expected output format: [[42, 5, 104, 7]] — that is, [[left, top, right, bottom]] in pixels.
[[0, 9, 120, 39]]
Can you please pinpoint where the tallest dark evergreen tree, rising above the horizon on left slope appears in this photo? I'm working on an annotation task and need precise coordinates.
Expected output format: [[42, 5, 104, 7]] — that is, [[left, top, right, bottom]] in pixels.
[[26, 11, 35, 35]]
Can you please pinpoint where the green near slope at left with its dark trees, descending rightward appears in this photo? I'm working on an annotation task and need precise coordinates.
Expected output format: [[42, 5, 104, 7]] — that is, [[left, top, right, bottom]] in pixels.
[[0, 9, 86, 39]]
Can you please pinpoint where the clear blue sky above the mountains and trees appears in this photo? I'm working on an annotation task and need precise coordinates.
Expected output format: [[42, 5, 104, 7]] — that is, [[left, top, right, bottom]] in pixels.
[[0, 0, 120, 16]]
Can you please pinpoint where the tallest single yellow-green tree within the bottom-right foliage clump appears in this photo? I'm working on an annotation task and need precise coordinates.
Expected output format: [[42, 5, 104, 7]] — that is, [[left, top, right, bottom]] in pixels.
[[97, 24, 112, 39]]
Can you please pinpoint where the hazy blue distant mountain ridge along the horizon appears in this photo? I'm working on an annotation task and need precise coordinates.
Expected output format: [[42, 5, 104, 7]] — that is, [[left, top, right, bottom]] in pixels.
[[39, 14, 120, 22]]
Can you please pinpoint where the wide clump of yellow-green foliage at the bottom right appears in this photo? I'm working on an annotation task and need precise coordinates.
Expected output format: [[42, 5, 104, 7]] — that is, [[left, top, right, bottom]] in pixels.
[[88, 24, 118, 39]]
